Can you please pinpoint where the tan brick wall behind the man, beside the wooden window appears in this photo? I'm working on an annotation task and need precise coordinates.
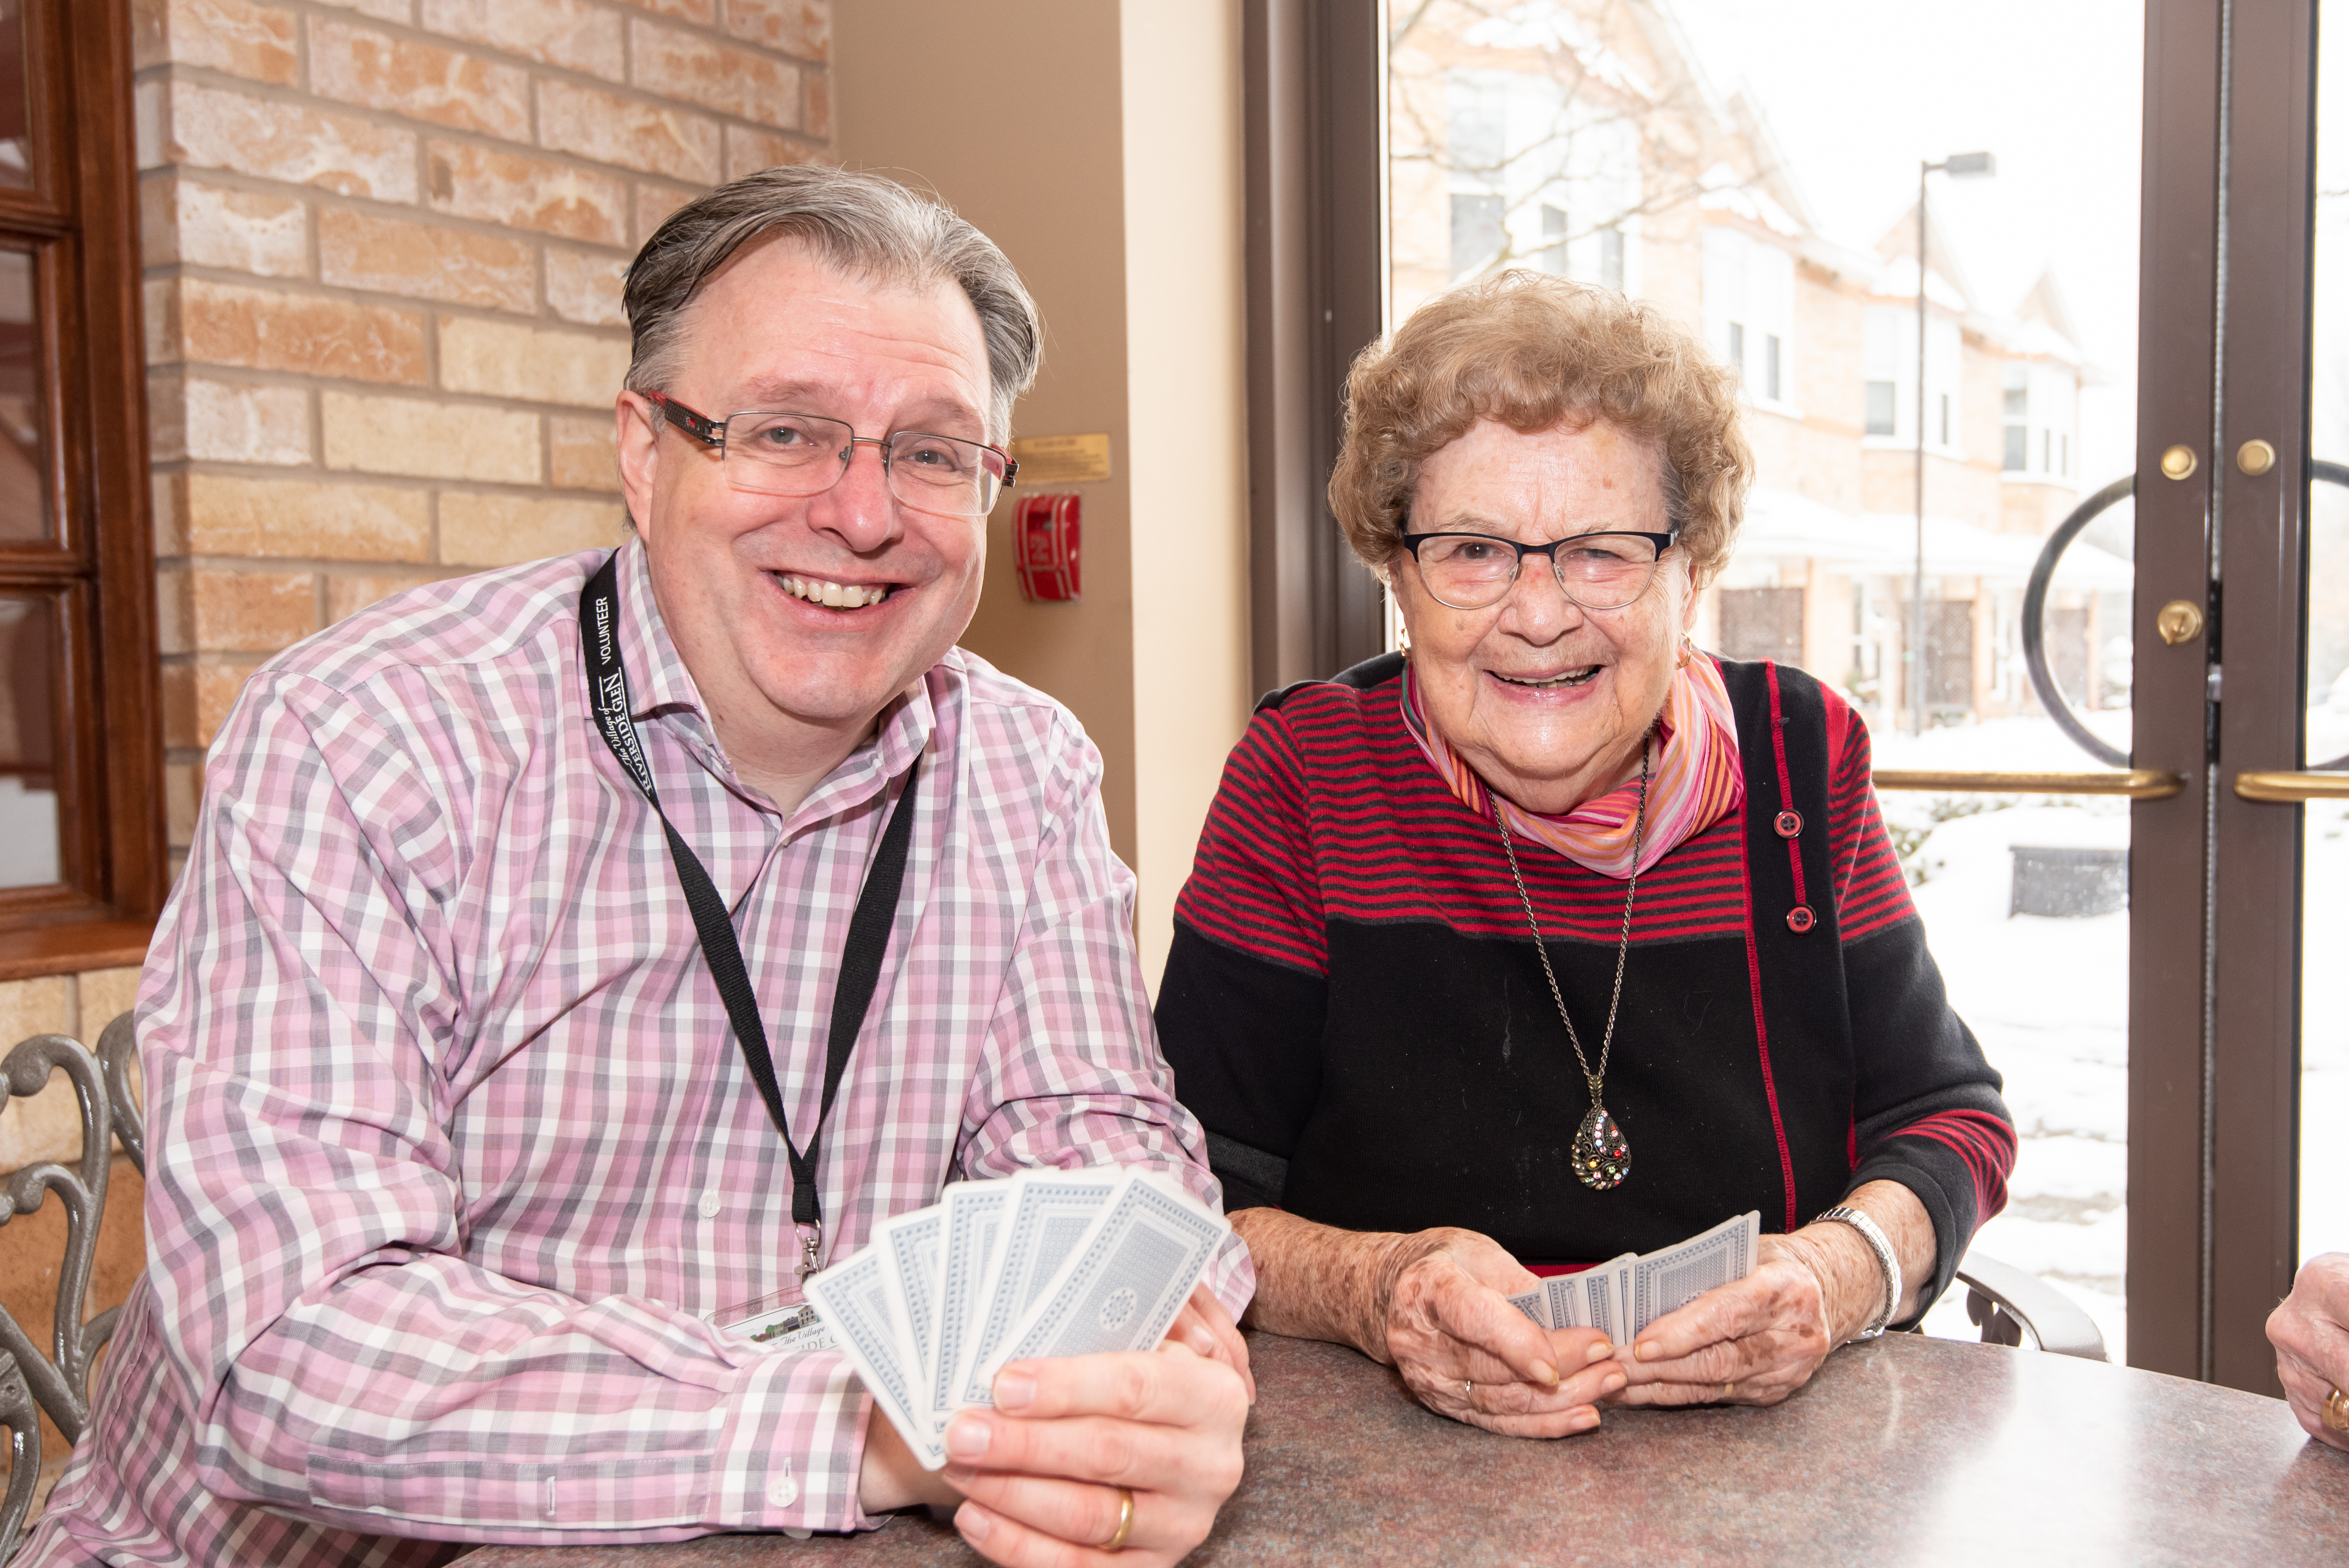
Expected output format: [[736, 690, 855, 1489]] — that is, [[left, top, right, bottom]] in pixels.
[[137, 0, 832, 864]]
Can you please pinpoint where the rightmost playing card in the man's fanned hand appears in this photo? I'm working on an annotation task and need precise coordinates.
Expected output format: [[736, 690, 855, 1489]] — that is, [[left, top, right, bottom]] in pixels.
[[980, 1171, 1231, 1383]]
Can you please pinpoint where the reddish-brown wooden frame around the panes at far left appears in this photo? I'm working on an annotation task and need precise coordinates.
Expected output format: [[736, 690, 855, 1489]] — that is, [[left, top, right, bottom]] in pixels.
[[0, 0, 169, 981]]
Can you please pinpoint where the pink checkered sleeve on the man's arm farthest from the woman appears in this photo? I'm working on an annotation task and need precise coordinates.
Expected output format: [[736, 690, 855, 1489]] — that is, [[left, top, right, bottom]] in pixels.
[[143, 674, 883, 1542]]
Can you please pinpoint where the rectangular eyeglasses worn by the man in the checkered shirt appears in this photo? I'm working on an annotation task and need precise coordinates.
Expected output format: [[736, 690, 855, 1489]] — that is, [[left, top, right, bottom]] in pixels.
[[644, 392, 1019, 516]]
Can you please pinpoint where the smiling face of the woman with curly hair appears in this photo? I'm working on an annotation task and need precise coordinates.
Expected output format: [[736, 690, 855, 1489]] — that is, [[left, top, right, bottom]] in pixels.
[[1388, 420, 1696, 814]]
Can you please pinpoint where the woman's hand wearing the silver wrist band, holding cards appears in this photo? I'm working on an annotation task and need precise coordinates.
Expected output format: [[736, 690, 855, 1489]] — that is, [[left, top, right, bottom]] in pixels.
[[1612, 1225, 1841, 1404]]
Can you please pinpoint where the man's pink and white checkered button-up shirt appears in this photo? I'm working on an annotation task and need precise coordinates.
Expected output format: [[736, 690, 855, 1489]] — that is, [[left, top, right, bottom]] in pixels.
[[23, 544, 1254, 1566]]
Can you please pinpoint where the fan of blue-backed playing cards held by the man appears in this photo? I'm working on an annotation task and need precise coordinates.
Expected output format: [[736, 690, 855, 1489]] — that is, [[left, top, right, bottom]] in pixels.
[[808, 1167, 1231, 1470]]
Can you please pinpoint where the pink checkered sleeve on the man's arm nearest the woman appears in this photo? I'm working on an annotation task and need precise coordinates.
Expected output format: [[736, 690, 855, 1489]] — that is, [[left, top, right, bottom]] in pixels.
[[961, 711, 1257, 1322]]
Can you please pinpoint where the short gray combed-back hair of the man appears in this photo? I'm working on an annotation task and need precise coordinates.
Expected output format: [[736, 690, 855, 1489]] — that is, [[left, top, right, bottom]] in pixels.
[[622, 164, 1043, 441]]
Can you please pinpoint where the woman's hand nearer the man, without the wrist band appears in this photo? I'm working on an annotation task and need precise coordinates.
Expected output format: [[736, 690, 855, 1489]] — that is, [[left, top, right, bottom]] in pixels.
[[1384, 1230, 1623, 1437]]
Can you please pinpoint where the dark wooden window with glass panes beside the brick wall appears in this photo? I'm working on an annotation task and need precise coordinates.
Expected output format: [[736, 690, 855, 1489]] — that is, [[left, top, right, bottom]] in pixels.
[[0, 0, 164, 929]]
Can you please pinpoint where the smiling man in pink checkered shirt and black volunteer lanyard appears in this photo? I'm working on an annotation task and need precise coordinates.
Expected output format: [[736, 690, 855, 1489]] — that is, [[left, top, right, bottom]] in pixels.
[[28, 169, 1252, 1566]]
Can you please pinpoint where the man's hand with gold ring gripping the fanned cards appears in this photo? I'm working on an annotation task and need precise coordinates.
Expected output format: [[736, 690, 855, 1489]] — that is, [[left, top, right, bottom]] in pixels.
[[940, 1333, 1247, 1568]]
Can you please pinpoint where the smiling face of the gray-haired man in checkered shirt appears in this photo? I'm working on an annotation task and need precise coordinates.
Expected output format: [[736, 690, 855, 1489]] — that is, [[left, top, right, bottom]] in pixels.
[[618, 239, 989, 808]]
